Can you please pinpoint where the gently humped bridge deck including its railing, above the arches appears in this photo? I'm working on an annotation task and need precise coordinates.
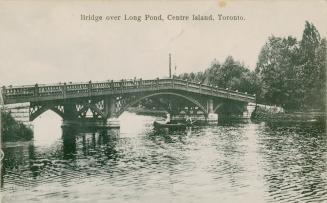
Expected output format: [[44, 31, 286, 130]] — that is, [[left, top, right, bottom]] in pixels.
[[2, 78, 255, 104]]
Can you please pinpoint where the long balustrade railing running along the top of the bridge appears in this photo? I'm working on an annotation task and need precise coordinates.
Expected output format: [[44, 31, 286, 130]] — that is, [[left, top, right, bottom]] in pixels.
[[2, 78, 254, 103]]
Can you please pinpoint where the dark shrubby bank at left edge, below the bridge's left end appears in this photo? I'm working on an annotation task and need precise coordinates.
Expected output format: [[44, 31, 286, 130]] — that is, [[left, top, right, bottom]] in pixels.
[[1, 112, 33, 141]]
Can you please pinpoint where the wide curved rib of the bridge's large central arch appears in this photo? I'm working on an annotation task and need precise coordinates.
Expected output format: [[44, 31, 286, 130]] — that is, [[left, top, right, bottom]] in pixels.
[[117, 92, 208, 117]]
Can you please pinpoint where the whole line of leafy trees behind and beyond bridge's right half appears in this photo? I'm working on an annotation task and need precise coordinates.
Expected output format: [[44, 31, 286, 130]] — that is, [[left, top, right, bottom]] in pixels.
[[177, 21, 327, 111]]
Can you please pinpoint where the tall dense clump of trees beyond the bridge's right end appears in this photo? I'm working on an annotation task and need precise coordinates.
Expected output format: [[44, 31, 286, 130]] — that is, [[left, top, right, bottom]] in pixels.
[[256, 22, 326, 110]]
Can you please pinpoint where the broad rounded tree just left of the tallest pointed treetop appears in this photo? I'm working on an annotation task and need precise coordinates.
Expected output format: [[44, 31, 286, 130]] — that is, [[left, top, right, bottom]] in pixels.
[[256, 36, 299, 109]]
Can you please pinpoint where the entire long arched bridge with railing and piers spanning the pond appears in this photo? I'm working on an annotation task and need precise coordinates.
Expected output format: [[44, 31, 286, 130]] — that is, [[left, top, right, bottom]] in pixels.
[[2, 78, 255, 126]]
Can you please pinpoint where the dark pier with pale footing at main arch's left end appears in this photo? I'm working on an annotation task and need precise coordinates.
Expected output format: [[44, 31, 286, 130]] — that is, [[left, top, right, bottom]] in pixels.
[[104, 97, 120, 128]]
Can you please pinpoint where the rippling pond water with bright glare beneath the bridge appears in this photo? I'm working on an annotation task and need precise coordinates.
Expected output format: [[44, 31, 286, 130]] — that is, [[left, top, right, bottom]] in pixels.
[[1, 113, 327, 202]]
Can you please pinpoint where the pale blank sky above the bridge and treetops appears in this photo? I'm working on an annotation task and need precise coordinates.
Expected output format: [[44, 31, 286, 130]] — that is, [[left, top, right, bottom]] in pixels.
[[0, 0, 327, 86]]
